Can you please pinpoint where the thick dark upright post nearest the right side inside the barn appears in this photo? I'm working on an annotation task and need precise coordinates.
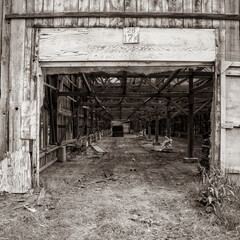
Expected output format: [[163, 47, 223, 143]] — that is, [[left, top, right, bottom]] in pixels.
[[188, 73, 194, 158]]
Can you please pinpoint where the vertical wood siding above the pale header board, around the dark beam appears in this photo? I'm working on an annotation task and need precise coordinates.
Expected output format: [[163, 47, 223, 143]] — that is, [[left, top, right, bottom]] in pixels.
[[15, 0, 240, 61]]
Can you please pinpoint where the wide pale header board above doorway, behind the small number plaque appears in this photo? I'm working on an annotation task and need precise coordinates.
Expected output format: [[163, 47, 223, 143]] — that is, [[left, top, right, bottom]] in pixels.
[[39, 28, 215, 61]]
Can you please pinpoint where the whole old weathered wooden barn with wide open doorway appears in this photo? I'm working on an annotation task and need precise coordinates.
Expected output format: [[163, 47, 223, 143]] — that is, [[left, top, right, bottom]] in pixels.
[[0, 0, 240, 193]]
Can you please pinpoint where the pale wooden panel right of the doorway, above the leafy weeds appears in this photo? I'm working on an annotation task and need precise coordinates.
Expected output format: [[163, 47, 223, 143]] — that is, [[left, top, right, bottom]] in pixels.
[[221, 62, 240, 172]]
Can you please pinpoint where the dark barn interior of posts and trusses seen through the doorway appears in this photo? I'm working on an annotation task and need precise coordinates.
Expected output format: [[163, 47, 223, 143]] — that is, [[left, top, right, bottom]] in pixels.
[[40, 64, 214, 172]]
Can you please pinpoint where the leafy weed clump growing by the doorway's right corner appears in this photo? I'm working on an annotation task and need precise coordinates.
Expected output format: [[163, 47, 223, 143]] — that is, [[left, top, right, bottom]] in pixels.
[[189, 169, 240, 230]]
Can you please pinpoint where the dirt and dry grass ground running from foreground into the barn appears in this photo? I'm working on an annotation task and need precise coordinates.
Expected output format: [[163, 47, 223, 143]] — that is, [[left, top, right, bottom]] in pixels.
[[0, 135, 240, 240]]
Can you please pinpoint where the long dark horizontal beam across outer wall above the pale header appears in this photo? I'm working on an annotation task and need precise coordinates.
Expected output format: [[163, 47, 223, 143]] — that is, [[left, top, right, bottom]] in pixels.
[[5, 12, 240, 21]]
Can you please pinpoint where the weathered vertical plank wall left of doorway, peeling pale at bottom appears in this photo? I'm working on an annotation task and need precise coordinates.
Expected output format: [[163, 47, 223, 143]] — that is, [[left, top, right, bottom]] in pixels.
[[0, 0, 39, 193]]
